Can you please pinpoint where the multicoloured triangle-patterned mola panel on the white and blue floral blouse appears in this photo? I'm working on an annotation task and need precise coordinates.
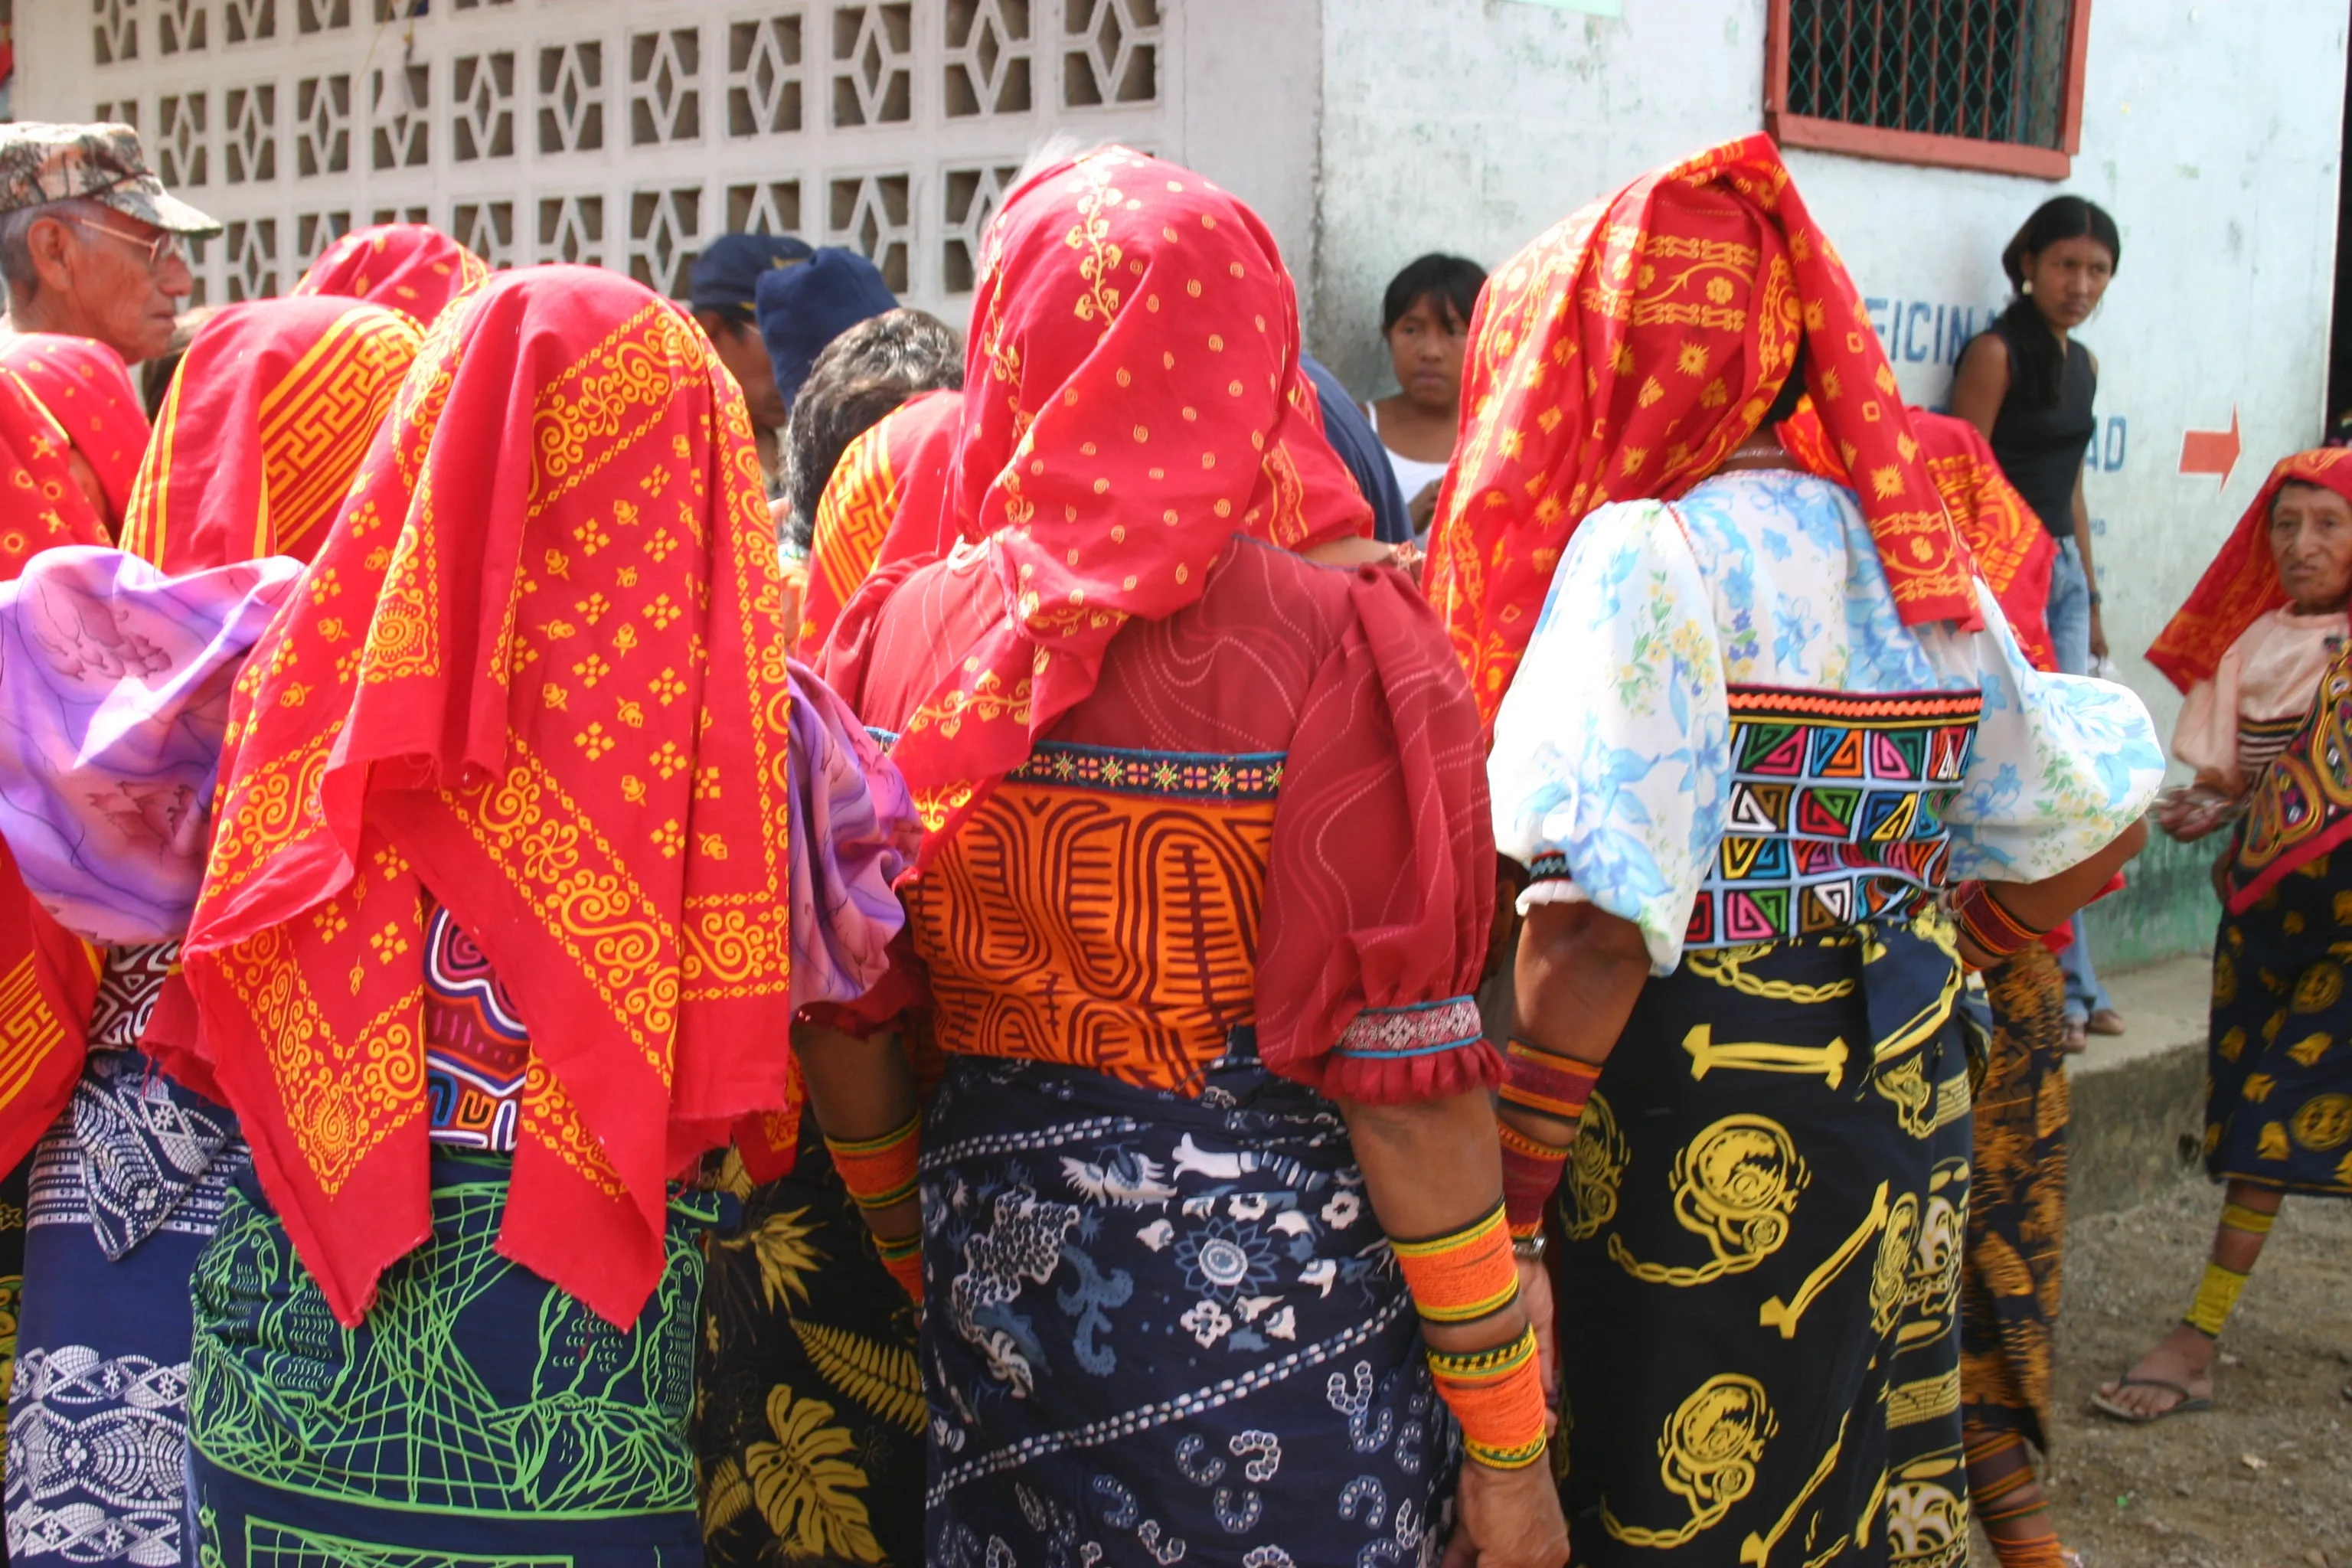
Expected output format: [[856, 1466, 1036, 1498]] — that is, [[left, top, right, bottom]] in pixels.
[[1684, 687, 1985, 947]]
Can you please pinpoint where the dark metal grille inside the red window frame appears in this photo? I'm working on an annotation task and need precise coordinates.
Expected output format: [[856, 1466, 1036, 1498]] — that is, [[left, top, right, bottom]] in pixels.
[[1788, 0, 2082, 151]]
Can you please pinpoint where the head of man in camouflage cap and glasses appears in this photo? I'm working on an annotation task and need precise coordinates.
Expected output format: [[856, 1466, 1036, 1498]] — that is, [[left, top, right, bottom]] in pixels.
[[0, 122, 221, 364]]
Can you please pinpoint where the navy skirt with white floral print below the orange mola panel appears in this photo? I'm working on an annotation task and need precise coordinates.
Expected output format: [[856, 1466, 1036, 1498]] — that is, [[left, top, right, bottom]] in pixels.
[[922, 1030, 1461, 1568]]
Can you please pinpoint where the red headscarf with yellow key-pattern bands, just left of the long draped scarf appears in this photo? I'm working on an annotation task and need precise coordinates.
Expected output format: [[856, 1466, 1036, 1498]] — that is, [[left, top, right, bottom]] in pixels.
[[122, 299, 423, 571]]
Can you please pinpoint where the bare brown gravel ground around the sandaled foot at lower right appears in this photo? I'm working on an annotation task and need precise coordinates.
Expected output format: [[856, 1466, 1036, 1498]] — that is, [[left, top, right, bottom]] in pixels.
[[2022, 1180, 2352, 1568]]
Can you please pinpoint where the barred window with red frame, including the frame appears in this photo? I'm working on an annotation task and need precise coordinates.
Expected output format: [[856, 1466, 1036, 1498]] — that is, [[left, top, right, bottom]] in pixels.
[[1764, 0, 2091, 178]]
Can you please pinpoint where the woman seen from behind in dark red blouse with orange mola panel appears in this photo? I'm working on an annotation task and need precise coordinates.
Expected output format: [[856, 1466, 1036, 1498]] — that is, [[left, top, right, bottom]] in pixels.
[[802, 148, 1566, 1566]]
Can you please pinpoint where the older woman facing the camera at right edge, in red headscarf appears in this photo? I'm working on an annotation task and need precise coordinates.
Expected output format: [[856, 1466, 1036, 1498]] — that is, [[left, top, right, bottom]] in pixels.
[[2091, 446, 2352, 1423]]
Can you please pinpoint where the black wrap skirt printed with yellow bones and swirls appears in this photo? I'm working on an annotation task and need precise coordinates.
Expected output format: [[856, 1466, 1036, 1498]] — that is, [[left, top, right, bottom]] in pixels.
[[1557, 916, 1968, 1568]]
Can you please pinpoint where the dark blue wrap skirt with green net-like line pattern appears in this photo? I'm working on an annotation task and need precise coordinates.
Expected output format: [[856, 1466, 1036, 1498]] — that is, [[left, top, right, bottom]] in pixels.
[[188, 1149, 720, 1568]]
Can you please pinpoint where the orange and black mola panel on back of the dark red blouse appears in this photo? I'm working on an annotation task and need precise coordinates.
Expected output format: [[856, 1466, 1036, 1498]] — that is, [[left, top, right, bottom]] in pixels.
[[908, 743, 1282, 1091]]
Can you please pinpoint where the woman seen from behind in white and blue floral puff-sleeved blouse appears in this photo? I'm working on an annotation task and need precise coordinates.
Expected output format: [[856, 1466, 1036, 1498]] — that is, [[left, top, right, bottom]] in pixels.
[[1432, 136, 2161, 1568]]
